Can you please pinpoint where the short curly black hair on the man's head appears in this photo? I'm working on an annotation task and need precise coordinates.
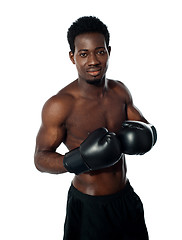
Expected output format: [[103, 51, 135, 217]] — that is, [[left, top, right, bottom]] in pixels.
[[67, 16, 110, 53]]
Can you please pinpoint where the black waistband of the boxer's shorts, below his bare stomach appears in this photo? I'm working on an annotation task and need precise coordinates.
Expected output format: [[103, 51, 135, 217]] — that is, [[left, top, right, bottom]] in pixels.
[[69, 180, 133, 202]]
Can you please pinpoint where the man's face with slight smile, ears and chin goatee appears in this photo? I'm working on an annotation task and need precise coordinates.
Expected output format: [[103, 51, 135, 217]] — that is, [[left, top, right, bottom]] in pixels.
[[70, 33, 110, 84]]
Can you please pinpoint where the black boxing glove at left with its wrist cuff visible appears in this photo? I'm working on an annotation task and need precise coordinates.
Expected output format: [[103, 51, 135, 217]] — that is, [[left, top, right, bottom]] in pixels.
[[63, 128, 122, 175]]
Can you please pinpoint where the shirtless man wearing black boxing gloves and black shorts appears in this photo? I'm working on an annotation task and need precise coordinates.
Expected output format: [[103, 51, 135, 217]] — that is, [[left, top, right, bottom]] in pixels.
[[35, 17, 157, 240]]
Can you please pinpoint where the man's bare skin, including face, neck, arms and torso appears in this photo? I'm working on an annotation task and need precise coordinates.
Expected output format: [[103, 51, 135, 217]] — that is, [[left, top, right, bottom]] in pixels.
[[35, 33, 148, 195]]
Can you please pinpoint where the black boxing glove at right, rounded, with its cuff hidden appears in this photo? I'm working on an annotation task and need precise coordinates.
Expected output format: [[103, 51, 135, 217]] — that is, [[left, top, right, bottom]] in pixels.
[[117, 121, 157, 155]]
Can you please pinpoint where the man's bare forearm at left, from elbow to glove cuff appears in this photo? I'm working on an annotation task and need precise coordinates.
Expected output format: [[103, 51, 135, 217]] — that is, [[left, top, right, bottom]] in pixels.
[[34, 151, 67, 174]]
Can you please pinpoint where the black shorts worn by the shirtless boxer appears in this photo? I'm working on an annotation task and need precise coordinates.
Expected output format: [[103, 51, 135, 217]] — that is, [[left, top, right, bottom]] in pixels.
[[63, 182, 149, 240]]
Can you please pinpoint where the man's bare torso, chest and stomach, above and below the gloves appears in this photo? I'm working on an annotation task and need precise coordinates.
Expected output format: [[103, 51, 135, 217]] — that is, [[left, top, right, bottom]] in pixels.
[[58, 80, 127, 195]]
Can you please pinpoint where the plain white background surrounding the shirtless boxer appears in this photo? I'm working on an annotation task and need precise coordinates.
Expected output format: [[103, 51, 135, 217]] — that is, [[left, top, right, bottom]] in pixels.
[[0, 0, 182, 240]]
